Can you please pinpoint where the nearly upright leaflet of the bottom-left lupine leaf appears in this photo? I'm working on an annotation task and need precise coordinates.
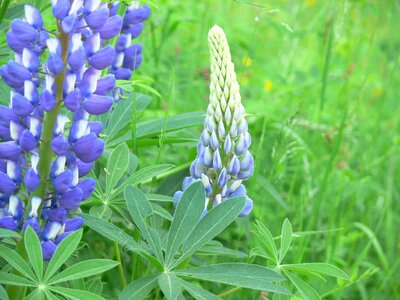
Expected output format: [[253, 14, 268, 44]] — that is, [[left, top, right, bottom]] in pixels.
[[24, 226, 43, 281]]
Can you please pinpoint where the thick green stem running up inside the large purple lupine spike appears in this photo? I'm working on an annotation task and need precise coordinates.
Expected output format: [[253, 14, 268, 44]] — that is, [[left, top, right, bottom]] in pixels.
[[25, 25, 70, 217]]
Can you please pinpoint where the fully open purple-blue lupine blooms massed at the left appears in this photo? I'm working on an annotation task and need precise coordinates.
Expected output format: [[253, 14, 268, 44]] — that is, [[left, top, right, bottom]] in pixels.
[[0, 0, 150, 259]]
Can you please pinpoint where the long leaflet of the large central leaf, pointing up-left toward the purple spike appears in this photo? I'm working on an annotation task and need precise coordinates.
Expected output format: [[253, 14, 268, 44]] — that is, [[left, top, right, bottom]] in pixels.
[[80, 213, 163, 270]]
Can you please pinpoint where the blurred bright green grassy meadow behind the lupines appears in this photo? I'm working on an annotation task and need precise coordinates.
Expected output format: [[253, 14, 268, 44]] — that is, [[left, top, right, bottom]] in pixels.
[[140, 0, 400, 299]]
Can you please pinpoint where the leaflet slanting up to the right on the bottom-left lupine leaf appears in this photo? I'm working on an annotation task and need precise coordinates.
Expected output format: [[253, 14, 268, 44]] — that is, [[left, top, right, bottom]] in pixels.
[[44, 230, 82, 282]]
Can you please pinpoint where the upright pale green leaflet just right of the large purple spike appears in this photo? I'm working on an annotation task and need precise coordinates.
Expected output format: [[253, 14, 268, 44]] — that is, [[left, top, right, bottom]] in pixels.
[[106, 143, 129, 195]]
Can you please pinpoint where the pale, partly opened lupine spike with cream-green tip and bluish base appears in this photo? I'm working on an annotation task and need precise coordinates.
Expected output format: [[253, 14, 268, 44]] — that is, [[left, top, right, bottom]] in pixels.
[[174, 26, 254, 216]]
